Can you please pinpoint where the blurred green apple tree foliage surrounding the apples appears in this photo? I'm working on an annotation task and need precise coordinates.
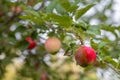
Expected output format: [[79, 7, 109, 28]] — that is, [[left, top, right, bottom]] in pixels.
[[0, 0, 120, 80]]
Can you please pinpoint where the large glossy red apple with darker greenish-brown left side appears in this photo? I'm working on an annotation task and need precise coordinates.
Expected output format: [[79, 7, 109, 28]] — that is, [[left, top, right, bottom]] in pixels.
[[75, 46, 96, 67]]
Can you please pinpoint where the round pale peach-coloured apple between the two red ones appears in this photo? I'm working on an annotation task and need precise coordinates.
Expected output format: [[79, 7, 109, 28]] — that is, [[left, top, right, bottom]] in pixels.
[[44, 37, 61, 54]]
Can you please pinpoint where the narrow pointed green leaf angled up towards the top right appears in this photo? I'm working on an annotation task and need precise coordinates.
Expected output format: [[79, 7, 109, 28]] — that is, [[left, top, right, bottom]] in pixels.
[[75, 4, 95, 20]]
